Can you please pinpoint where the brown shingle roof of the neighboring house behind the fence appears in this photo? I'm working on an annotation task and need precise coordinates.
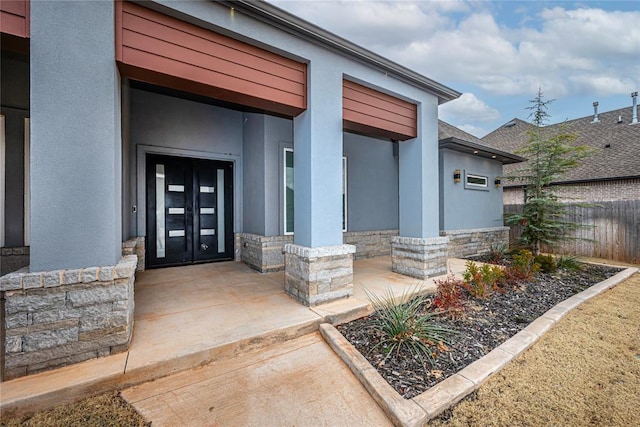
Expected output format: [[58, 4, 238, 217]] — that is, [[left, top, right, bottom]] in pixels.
[[482, 107, 640, 182]]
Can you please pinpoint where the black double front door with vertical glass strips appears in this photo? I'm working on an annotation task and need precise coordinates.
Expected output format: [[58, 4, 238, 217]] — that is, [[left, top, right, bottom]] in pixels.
[[146, 154, 234, 268]]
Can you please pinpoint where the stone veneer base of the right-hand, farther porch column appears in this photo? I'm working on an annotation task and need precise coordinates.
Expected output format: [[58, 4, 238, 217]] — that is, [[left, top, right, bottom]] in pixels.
[[391, 236, 449, 280]]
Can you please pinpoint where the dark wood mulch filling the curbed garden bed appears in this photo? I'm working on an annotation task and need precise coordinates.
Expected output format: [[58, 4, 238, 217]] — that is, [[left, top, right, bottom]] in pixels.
[[338, 265, 620, 399]]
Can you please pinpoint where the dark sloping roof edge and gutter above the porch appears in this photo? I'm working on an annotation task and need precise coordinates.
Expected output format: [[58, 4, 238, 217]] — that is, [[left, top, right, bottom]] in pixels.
[[224, 0, 462, 104]]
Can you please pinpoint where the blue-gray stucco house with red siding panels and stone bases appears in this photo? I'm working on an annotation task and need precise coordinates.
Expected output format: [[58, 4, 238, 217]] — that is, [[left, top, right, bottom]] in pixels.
[[0, 0, 506, 378]]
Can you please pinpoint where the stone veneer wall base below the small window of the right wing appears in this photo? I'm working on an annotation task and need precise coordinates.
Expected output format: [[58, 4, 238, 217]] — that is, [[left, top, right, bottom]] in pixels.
[[440, 227, 509, 258]]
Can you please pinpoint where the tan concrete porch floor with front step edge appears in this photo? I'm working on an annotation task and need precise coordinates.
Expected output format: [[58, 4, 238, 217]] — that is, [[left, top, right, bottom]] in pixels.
[[0, 257, 464, 416]]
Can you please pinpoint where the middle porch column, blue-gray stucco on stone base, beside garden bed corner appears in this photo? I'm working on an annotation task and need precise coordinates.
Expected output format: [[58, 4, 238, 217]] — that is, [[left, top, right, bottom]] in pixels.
[[284, 61, 355, 305]]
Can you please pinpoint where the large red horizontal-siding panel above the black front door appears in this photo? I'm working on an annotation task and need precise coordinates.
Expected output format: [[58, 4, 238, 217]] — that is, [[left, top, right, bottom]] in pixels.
[[116, 2, 307, 117]]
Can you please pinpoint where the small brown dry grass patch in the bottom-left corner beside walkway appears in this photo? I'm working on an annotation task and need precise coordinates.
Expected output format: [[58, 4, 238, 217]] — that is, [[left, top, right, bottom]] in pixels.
[[0, 392, 151, 427]]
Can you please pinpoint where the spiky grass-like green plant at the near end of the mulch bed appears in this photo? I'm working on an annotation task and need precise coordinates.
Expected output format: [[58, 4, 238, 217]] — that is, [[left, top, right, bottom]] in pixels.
[[367, 289, 455, 365]]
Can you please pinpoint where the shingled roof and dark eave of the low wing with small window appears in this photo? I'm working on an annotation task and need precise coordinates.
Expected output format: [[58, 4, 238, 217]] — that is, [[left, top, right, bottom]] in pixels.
[[438, 120, 525, 165]]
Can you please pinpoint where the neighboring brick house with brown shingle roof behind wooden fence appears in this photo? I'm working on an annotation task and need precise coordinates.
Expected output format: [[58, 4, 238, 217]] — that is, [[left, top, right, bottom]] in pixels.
[[482, 101, 640, 205]]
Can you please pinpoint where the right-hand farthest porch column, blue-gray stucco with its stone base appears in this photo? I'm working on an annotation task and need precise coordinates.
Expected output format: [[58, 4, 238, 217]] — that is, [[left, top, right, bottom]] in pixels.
[[391, 97, 449, 279]]
